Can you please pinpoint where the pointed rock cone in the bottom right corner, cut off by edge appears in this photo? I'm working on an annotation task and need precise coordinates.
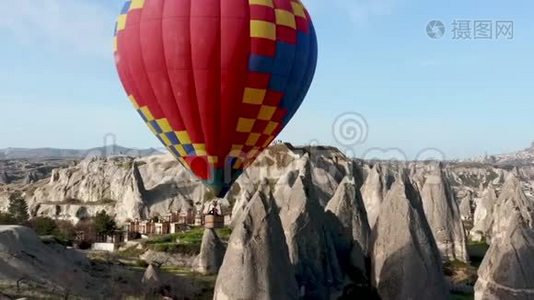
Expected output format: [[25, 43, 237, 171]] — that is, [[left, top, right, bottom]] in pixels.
[[475, 175, 534, 300]]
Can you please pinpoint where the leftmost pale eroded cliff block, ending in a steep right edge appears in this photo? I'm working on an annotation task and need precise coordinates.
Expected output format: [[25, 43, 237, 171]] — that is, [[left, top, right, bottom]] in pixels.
[[29, 157, 148, 221]]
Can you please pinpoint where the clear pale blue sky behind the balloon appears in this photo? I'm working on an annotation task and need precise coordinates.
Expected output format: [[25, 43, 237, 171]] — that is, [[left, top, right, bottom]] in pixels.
[[0, 0, 534, 159]]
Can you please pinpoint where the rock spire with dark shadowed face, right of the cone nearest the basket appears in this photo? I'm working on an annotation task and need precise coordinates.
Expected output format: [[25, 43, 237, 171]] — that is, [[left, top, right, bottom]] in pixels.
[[274, 171, 352, 299]]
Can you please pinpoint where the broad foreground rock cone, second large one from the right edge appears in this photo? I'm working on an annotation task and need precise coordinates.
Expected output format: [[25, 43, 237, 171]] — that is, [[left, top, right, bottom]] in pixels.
[[371, 178, 449, 300]]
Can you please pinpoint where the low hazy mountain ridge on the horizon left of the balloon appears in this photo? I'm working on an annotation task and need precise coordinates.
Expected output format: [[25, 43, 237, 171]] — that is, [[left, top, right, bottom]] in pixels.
[[0, 145, 161, 159]]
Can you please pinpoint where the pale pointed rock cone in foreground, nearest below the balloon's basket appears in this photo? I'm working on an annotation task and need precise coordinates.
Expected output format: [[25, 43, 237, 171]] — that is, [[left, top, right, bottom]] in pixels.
[[214, 188, 298, 300]]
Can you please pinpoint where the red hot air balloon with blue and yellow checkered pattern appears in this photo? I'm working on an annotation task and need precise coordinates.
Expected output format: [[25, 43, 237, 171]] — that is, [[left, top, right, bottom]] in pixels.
[[114, 0, 317, 197]]
